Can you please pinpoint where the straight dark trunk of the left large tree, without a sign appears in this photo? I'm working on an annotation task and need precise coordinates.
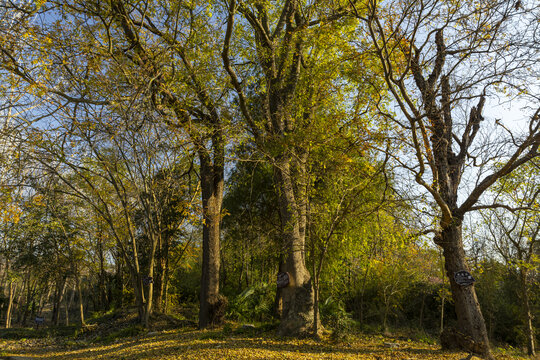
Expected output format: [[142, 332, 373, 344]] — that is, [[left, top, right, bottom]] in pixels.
[[199, 149, 226, 329]]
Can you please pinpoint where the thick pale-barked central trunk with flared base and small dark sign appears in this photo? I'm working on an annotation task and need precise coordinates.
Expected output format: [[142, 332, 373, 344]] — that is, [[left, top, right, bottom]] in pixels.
[[275, 157, 314, 336]]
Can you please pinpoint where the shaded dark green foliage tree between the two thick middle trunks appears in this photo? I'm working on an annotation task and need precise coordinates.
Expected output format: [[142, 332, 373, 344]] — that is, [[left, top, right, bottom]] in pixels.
[[222, 146, 282, 292]]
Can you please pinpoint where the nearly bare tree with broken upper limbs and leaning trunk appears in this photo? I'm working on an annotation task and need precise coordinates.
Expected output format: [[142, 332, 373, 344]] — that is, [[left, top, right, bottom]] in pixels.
[[356, 0, 540, 358]]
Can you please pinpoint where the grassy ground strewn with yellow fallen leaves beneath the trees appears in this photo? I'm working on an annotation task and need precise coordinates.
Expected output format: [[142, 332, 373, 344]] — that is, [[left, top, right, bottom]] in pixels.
[[0, 325, 524, 360]]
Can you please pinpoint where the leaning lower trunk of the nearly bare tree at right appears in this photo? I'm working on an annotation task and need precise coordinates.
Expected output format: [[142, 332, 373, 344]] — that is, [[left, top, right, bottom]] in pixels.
[[437, 224, 492, 359]]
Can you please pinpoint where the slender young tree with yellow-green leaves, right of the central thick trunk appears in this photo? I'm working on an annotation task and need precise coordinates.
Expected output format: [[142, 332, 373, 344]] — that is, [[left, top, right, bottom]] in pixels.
[[307, 134, 392, 336]]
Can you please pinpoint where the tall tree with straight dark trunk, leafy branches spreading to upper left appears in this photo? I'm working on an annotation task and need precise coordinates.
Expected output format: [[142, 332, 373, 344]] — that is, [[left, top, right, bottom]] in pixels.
[[0, 1, 227, 327]]
